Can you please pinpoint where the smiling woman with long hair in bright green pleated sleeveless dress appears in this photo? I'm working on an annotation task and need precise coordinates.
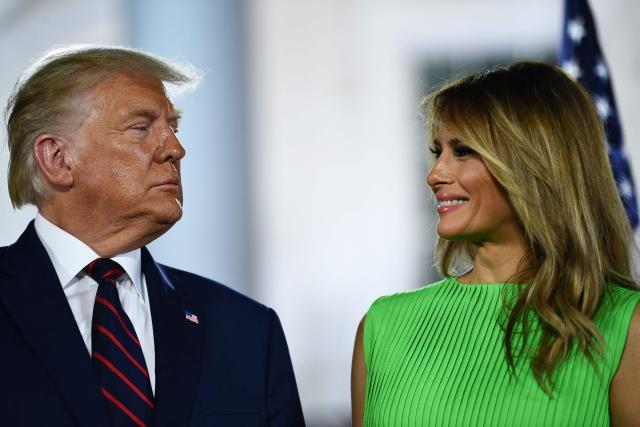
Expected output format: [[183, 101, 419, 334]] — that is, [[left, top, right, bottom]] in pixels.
[[352, 62, 640, 427]]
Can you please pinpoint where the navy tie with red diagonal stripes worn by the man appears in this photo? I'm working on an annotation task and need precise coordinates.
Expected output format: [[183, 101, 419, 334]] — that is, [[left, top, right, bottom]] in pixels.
[[84, 258, 154, 427]]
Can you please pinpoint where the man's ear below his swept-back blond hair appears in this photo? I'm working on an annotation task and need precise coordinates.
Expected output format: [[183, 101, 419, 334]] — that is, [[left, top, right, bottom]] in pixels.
[[33, 133, 73, 188]]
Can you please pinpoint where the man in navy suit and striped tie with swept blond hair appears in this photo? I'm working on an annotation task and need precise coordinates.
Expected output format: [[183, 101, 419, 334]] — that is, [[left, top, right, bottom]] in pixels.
[[0, 47, 304, 427]]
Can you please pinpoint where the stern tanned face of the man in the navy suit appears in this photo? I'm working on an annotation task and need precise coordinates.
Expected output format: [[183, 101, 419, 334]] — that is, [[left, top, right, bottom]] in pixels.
[[70, 74, 185, 237]]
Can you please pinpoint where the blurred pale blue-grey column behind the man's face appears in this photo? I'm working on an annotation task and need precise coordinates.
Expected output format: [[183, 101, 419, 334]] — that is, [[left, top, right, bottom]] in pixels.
[[128, 0, 250, 291]]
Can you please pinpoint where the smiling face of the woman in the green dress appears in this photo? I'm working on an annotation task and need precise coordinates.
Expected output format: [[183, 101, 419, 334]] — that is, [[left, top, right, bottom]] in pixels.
[[427, 125, 522, 244]]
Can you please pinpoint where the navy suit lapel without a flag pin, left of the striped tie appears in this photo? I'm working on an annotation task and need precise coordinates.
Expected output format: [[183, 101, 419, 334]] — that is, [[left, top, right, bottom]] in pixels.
[[0, 226, 107, 426]]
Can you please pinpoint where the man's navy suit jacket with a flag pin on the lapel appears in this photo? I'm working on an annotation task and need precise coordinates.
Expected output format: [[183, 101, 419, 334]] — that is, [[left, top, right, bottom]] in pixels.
[[0, 222, 304, 427]]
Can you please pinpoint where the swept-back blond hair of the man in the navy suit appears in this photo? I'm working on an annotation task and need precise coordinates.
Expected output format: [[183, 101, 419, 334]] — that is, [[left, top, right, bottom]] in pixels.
[[5, 46, 199, 208]]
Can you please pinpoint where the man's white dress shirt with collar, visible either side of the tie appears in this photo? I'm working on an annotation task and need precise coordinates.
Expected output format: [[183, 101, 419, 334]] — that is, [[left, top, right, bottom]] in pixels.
[[35, 214, 156, 394]]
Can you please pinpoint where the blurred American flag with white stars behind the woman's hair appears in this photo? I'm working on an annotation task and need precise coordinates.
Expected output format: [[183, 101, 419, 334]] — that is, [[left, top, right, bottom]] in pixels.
[[558, 0, 638, 230]]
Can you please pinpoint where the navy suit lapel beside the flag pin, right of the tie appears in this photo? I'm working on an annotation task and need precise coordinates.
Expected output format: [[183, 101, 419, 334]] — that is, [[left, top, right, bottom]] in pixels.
[[142, 248, 203, 426]]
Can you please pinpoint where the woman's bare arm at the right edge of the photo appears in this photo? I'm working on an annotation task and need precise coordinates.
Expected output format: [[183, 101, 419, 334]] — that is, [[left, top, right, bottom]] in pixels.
[[609, 305, 640, 427]]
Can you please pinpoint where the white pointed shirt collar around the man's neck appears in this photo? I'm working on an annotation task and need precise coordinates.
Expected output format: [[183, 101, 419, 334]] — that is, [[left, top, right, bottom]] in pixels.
[[34, 213, 144, 298]]
